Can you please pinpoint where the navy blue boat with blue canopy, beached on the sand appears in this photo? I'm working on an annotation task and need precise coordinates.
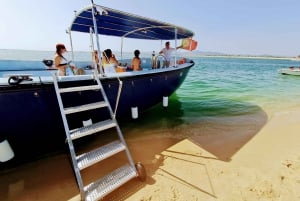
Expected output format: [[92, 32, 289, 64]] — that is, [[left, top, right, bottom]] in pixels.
[[0, 4, 195, 169]]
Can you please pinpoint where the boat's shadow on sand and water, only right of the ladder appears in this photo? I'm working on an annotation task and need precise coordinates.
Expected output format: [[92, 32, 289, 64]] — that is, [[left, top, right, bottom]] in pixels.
[[104, 94, 267, 200]]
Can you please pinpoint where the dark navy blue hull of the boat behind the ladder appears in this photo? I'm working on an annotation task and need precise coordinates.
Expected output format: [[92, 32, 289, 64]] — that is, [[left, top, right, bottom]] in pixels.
[[0, 62, 194, 169]]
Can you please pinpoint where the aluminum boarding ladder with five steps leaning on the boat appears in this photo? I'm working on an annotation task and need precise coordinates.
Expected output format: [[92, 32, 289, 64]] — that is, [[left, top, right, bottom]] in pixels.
[[52, 73, 146, 201]]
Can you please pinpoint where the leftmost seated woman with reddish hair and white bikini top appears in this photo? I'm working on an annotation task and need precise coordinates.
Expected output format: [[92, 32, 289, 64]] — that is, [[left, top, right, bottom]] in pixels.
[[54, 44, 76, 76]]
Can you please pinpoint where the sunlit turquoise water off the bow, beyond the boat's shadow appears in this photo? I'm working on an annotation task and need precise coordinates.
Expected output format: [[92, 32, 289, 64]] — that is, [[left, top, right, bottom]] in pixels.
[[183, 58, 300, 115]]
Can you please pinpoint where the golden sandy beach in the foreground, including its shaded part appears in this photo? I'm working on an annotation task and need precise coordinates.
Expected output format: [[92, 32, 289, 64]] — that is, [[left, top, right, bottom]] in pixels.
[[0, 109, 300, 201]]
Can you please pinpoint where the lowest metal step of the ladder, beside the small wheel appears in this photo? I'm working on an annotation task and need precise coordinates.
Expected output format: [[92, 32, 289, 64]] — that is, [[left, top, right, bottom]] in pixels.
[[84, 164, 137, 201]]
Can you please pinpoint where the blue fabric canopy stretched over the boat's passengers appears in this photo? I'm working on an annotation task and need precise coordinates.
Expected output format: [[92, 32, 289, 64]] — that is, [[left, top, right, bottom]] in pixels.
[[70, 5, 194, 40]]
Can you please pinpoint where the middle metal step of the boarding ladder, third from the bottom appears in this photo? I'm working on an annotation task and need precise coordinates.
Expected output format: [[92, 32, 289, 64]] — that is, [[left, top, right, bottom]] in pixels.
[[70, 119, 117, 140]]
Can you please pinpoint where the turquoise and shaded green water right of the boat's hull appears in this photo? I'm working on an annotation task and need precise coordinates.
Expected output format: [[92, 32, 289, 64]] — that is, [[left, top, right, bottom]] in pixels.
[[119, 55, 300, 142]]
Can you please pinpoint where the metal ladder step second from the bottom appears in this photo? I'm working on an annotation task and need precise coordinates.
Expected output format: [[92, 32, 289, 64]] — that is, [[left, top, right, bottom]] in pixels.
[[76, 141, 126, 170]]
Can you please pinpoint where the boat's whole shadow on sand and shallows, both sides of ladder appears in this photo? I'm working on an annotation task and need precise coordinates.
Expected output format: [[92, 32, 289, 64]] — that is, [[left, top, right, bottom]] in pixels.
[[0, 95, 267, 200]]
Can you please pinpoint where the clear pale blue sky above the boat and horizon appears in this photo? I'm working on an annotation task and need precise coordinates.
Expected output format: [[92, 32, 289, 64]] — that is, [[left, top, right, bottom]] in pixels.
[[0, 0, 300, 56]]
